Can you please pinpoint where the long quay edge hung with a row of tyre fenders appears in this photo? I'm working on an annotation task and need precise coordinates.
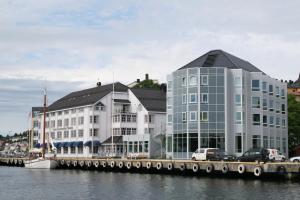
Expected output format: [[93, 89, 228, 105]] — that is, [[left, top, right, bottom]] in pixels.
[[0, 158, 300, 178]]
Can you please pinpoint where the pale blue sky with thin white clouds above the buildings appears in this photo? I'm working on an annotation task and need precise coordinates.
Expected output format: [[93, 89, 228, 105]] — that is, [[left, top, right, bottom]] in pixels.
[[0, 0, 300, 135]]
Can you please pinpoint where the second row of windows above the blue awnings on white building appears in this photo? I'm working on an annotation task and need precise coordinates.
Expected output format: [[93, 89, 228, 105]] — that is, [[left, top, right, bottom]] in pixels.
[[46, 115, 99, 128]]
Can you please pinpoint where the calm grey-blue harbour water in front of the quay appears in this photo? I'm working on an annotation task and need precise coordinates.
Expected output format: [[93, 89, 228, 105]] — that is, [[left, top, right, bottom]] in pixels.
[[0, 167, 300, 200]]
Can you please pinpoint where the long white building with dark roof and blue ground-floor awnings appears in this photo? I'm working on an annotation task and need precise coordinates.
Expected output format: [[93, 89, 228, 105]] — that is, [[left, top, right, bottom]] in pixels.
[[37, 82, 166, 157]]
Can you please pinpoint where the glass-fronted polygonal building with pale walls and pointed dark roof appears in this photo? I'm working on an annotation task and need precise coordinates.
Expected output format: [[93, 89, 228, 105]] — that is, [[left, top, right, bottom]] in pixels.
[[167, 50, 288, 159]]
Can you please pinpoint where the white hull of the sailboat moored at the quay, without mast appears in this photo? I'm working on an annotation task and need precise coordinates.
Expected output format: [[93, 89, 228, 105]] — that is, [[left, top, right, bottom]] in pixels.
[[24, 157, 58, 169]]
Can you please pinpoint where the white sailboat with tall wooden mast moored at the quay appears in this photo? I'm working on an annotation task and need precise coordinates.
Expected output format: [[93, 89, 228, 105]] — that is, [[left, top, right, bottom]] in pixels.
[[24, 89, 58, 169]]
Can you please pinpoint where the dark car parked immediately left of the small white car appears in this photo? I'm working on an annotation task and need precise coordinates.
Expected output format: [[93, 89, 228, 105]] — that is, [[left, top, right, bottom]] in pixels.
[[238, 148, 269, 162]]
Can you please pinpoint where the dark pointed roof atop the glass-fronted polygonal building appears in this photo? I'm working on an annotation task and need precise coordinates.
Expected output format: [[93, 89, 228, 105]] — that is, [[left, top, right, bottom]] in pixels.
[[179, 50, 262, 72]]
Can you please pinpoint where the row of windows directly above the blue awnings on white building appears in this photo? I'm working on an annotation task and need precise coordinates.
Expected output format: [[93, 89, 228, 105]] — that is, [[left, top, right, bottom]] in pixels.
[[50, 128, 98, 139]]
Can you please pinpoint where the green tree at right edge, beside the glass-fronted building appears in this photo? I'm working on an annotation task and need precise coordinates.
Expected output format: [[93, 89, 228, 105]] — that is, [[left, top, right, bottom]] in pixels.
[[288, 95, 300, 154]]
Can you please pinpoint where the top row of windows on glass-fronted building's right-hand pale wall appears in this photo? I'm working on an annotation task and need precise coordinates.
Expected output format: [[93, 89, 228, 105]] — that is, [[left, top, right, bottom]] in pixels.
[[252, 80, 285, 99]]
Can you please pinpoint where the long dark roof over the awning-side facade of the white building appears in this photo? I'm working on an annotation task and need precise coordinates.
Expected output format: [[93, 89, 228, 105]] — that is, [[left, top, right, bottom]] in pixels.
[[48, 82, 128, 111]]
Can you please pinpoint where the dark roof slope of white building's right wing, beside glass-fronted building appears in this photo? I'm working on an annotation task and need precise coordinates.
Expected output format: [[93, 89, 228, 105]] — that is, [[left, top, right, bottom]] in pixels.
[[130, 88, 166, 112]]
